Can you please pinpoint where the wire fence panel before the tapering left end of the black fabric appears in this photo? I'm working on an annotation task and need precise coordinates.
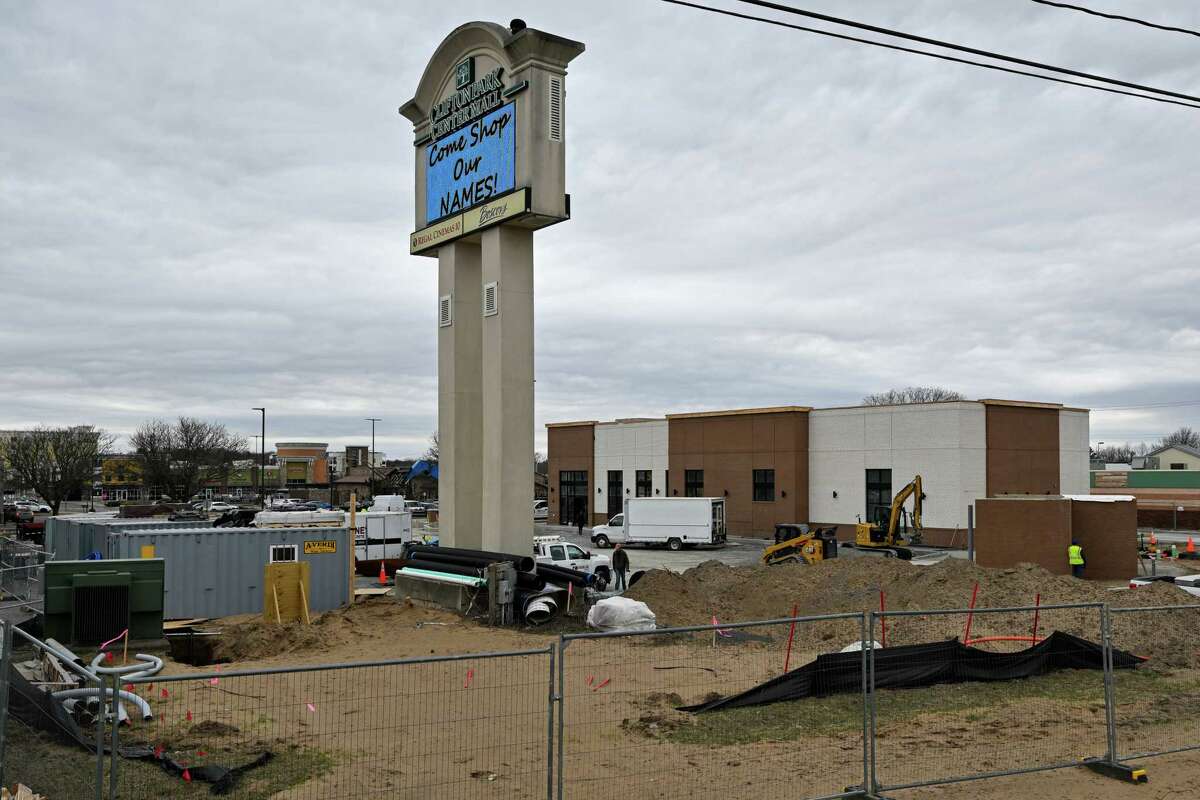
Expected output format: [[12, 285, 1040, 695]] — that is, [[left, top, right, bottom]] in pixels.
[[556, 614, 865, 800]]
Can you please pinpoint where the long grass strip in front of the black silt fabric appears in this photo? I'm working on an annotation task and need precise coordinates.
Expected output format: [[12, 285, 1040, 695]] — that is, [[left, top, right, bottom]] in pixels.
[[661, 670, 1200, 745]]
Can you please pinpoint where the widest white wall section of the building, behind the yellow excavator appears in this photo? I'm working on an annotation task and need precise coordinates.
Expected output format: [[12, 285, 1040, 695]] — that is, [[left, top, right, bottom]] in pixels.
[[809, 402, 984, 530]]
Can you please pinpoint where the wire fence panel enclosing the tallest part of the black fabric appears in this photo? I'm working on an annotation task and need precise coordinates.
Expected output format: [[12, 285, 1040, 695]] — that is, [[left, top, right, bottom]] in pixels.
[[870, 604, 1108, 792]]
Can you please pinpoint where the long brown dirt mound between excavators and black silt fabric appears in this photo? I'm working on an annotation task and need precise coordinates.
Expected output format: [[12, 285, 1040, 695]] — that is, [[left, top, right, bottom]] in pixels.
[[626, 558, 1200, 666]]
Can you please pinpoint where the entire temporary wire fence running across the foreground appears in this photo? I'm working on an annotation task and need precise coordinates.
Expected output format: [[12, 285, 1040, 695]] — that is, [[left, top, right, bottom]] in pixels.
[[7, 604, 1200, 800]]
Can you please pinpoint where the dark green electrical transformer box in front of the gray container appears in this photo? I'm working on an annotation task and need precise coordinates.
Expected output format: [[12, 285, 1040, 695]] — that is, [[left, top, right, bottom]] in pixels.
[[43, 558, 164, 645]]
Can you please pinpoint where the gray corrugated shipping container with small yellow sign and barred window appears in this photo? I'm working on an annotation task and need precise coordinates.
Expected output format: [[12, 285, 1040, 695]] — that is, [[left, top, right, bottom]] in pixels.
[[108, 528, 350, 619]]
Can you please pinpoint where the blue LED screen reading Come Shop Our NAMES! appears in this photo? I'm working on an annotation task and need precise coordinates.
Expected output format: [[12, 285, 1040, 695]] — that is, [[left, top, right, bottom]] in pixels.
[[425, 103, 517, 223]]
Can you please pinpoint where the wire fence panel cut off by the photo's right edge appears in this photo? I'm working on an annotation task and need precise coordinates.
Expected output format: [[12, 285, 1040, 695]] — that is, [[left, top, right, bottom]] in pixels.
[[1109, 604, 1200, 760]]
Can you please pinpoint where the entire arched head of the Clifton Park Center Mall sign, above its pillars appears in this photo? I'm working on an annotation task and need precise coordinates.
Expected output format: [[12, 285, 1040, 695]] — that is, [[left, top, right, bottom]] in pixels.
[[400, 20, 583, 255]]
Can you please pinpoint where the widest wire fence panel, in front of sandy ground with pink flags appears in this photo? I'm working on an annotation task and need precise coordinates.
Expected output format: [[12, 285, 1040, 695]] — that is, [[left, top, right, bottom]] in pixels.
[[118, 646, 554, 800]]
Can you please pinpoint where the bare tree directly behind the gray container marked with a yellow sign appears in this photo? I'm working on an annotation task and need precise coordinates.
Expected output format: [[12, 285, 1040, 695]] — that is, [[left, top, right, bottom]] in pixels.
[[132, 416, 246, 499]]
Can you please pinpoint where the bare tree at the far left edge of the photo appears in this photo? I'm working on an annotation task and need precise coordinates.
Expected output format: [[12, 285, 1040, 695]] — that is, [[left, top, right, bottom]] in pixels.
[[0, 425, 114, 513]]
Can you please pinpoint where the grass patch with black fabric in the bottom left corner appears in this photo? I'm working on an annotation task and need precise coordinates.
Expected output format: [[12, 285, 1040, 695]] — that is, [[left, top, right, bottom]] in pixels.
[[5, 720, 336, 800]]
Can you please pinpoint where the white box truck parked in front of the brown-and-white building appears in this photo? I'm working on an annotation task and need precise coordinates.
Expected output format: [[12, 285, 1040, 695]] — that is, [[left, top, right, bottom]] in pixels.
[[592, 498, 726, 551]]
